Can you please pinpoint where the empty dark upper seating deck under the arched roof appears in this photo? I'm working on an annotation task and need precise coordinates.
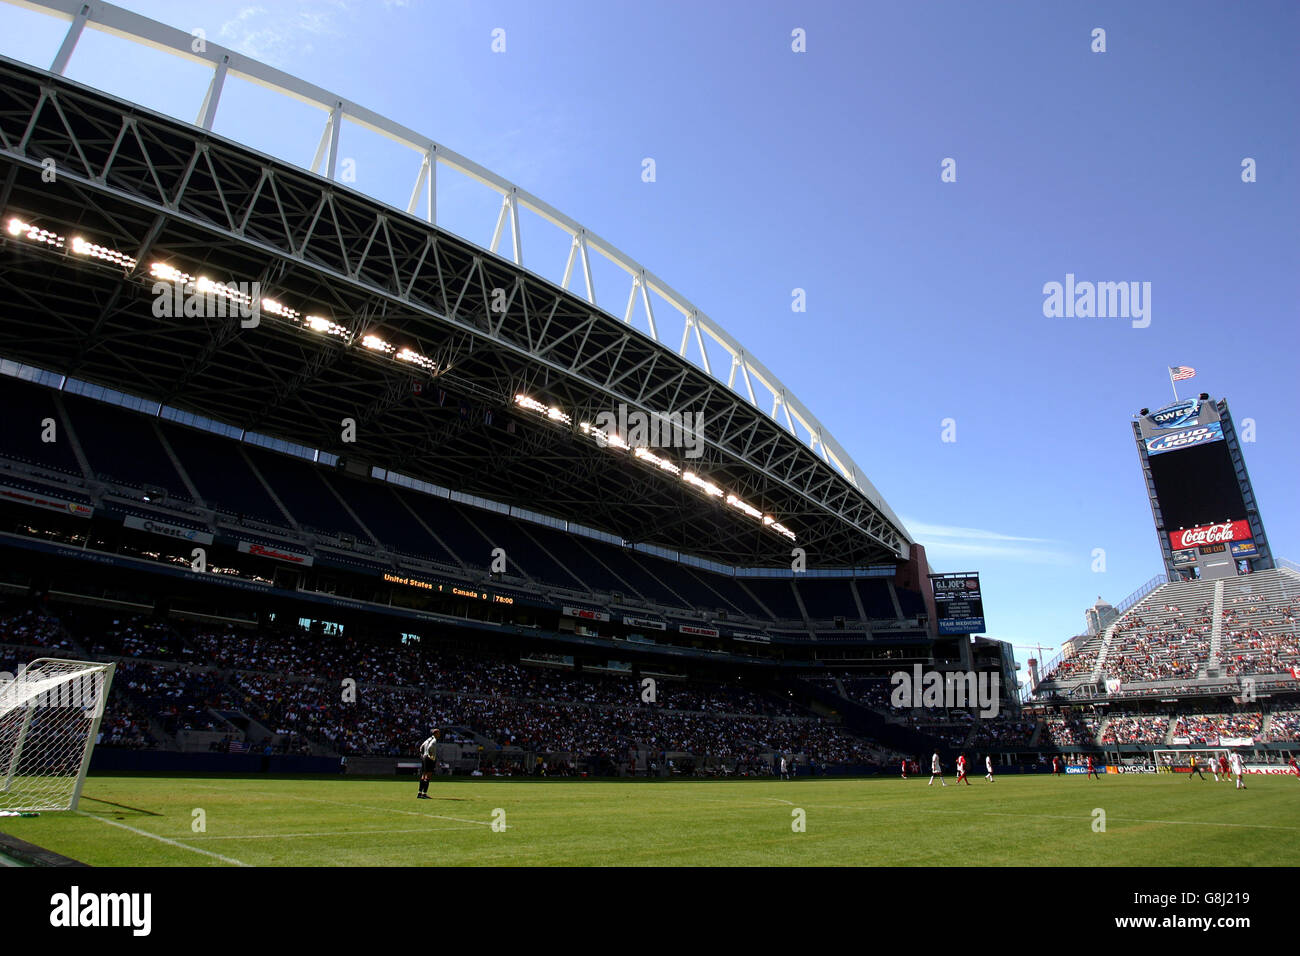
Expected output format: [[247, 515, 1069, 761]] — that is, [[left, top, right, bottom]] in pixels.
[[0, 376, 941, 640]]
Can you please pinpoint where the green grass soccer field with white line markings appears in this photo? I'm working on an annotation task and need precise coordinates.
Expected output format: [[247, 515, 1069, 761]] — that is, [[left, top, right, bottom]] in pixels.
[[0, 775, 1300, 866]]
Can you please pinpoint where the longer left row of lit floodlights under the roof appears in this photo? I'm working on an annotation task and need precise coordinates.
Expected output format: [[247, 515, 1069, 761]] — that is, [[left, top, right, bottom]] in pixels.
[[5, 216, 438, 375]]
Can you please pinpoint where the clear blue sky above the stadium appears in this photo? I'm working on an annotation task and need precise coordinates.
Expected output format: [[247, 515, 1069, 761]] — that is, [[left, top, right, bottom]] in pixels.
[[0, 0, 1300, 661]]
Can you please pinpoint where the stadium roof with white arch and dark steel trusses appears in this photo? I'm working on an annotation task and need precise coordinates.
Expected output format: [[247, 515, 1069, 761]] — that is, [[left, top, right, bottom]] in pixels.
[[0, 3, 910, 567]]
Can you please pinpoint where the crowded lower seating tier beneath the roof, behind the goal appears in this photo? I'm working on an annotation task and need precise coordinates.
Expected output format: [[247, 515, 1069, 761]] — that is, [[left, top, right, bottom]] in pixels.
[[0, 610, 881, 765]]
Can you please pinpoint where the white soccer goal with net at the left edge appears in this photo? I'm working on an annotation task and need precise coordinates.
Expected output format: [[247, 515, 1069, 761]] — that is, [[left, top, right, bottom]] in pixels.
[[0, 657, 117, 812]]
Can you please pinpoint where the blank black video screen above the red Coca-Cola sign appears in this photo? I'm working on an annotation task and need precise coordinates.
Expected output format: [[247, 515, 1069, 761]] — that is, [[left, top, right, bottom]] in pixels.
[[1151, 441, 1245, 531]]
